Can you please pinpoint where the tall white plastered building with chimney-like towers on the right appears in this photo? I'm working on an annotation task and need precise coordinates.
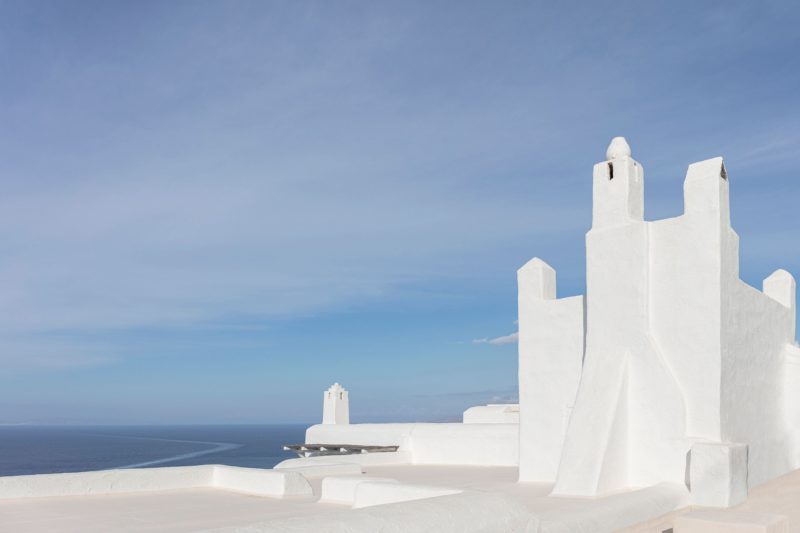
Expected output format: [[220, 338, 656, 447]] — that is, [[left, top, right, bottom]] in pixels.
[[518, 137, 800, 505]]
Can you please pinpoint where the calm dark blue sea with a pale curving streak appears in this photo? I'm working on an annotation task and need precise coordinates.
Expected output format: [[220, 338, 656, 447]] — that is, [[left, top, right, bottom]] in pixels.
[[0, 424, 307, 476]]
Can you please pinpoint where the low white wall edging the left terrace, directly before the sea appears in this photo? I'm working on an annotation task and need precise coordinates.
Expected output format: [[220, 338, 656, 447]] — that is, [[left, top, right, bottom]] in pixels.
[[0, 465, 313, 499]]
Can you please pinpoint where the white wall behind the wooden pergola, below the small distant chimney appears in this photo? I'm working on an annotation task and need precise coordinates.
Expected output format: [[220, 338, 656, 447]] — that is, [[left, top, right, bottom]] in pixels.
[[304, 423, 519, 466]]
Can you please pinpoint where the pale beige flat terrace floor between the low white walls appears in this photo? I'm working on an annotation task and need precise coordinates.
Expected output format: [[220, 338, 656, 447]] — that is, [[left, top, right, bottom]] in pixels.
[[0, 465, 800, 533]]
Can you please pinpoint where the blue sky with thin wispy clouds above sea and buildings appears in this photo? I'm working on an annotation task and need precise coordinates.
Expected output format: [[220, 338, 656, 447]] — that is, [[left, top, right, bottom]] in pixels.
[[0, 0, 800, 424]]
